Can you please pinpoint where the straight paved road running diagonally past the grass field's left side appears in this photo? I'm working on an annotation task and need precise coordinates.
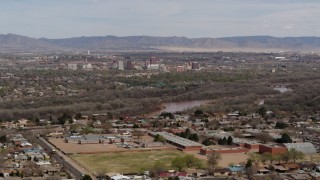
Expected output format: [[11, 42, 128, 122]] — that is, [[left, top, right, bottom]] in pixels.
[[23, 131, 95, 180]]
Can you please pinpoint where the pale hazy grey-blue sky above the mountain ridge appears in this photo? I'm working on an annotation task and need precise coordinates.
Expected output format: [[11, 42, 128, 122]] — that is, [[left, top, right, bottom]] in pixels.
[[0, 0, 320, 38]]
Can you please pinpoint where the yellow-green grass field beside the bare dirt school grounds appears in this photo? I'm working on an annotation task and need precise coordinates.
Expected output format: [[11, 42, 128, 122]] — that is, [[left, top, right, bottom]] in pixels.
[[71, 150, 190, 173]]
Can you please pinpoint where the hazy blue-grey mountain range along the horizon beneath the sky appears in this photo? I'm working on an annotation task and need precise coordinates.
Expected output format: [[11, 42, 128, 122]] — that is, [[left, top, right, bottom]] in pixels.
[[0, 34, 320, 52]]
